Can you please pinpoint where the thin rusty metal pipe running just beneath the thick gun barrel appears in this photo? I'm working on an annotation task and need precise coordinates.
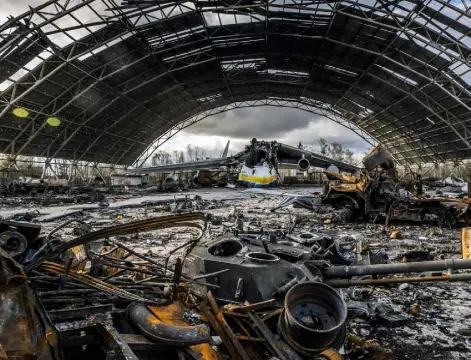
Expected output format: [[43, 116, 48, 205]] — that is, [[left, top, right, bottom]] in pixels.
[[325, 274, 471, 288]]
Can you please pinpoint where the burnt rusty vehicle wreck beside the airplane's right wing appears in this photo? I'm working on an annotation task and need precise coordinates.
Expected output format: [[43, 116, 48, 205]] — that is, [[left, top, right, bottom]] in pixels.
[[322, 146, 469, 226]]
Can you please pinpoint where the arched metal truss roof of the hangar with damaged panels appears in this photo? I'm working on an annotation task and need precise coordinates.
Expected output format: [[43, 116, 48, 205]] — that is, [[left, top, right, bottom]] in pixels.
[[0, 0, 471, 165]]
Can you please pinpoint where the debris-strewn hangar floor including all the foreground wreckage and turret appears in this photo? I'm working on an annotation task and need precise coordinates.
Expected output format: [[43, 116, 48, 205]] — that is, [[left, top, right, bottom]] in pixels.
[[0, 184, 471, 360]]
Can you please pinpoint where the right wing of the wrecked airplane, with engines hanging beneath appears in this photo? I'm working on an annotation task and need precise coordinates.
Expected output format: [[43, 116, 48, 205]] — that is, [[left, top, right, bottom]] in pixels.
[[277, 144, 359, 172]]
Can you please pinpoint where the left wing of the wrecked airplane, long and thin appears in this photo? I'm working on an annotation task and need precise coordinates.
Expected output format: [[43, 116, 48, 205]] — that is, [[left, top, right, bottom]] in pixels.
[[127, 157, 239, 174]]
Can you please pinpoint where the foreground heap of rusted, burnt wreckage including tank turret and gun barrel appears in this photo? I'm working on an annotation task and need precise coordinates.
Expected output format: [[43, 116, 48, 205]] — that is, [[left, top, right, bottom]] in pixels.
[[0, 212, 471, 360]]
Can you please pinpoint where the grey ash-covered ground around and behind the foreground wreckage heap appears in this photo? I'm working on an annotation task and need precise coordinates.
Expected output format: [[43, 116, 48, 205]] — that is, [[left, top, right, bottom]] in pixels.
[[0, 187, 471, 360]]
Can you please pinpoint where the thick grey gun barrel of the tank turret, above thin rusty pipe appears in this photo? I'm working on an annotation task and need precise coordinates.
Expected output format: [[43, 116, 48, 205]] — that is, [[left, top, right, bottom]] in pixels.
[[322, 259, 471, 279]]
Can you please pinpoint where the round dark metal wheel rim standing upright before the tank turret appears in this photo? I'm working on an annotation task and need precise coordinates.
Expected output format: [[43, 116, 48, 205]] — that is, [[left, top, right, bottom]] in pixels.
[[280, 282, 347, 353]]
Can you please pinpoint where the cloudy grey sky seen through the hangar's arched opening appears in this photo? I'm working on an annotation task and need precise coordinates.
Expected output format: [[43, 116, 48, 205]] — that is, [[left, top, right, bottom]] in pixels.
[[161, 106, 371, 156]]
